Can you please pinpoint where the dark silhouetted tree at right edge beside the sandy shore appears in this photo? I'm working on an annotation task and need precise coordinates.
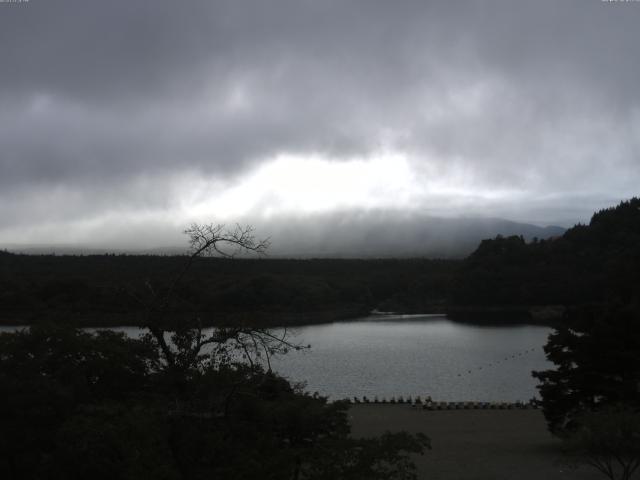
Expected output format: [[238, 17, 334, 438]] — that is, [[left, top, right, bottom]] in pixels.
[[534, 305, 640, 434]]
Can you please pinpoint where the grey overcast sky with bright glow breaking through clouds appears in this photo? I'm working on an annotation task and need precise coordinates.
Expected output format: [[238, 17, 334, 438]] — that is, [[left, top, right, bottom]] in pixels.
[[0, 0, 640, 251]]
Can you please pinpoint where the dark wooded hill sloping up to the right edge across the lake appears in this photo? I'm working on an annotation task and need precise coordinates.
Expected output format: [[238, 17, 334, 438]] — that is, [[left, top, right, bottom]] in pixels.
[[451, 198, 640, 305]]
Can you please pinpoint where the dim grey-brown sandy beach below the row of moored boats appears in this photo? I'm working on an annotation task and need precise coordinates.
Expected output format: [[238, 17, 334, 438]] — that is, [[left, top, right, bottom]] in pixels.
[[350, 405, 603, 480]]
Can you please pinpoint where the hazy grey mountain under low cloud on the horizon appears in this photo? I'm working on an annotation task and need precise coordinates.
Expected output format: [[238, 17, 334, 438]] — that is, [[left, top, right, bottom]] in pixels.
[[4, 210, 565, 258]]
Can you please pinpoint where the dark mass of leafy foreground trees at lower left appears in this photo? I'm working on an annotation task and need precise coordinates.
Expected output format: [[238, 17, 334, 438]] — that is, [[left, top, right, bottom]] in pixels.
[[0, 326, 428, 480]]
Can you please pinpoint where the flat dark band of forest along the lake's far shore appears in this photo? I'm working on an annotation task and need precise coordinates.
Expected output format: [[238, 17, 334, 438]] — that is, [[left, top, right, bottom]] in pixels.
[[0, 253, 457, 325]]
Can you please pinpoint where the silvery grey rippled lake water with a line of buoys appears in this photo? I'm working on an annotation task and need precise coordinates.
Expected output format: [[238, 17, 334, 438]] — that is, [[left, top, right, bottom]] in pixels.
[[0, 315, 552, 401]]
